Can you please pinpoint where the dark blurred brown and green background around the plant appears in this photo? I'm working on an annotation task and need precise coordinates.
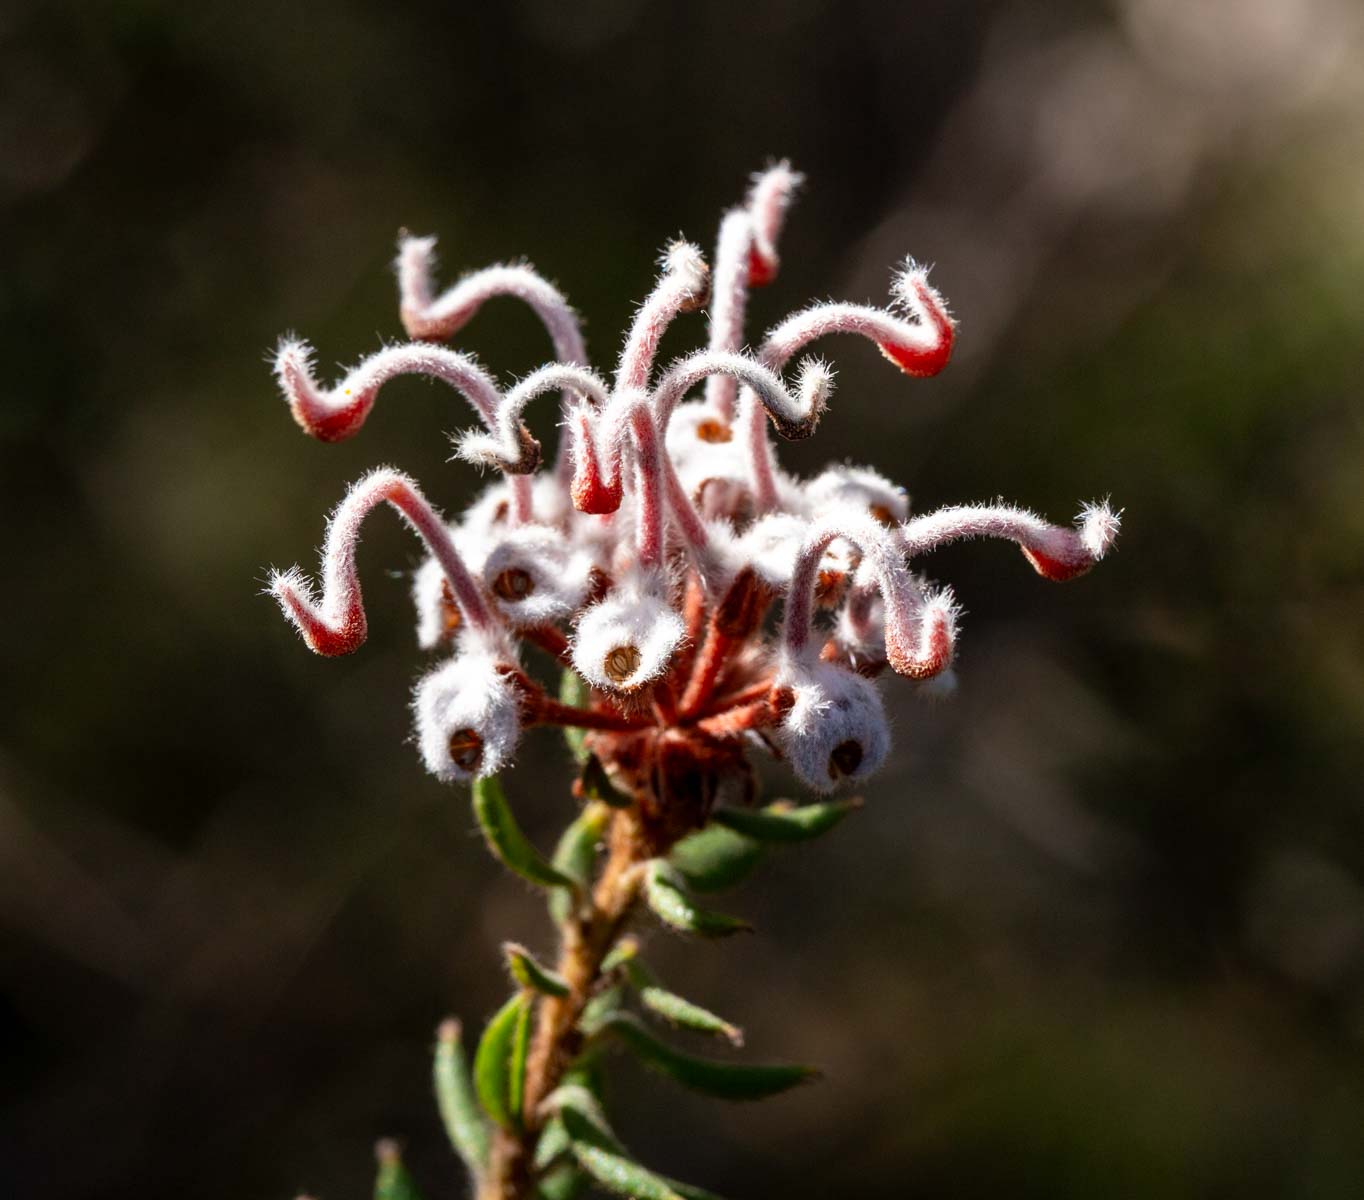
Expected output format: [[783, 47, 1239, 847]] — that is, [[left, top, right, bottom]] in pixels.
[[0, 0, 1364, 1200]]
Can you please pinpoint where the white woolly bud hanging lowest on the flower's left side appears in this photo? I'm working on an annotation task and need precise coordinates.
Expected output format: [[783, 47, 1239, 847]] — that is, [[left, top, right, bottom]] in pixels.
[[412, 649, 521, 783]]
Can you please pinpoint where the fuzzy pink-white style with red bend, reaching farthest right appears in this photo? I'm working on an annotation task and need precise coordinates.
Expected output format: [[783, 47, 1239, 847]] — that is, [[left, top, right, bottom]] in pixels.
[[899, 503, 1123, 582]]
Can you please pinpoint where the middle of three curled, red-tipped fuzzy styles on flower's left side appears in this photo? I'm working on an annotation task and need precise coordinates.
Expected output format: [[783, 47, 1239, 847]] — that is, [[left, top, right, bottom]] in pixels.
[[274, 338, 501, 442]]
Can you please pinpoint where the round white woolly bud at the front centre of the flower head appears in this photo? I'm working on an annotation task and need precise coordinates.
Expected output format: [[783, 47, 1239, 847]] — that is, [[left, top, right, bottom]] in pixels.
[[573, 592, 686, 691]]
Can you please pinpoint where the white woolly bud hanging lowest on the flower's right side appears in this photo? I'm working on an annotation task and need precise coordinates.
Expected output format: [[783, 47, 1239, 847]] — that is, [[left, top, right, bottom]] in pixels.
[[775, 659, 891, 792]]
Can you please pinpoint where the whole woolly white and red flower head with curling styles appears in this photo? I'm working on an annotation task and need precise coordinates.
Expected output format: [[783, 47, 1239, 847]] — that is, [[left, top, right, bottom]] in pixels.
[[270, 164, 1118, 825]]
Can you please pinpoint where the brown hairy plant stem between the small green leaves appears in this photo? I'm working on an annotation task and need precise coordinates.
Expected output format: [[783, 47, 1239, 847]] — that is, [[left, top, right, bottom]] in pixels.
[[479, 806, 663, 1200]]
